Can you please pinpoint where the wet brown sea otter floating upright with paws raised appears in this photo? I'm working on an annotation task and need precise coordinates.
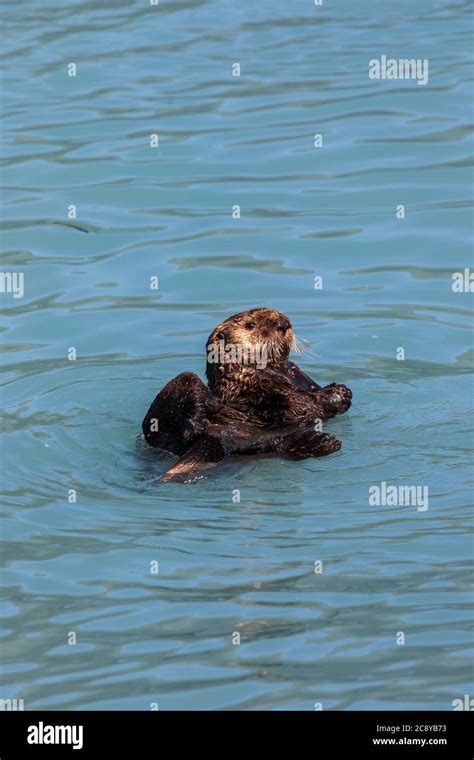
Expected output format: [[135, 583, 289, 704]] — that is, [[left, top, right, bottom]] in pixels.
[[142, 307, 352, 482]]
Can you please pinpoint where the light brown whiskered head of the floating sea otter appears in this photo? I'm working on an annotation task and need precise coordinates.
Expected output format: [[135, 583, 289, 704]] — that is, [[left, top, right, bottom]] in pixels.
[[206, 307, 295, 391]]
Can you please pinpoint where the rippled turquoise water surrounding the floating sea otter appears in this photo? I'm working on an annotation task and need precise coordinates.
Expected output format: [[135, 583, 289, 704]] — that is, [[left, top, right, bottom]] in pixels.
[[0, 0, 473, 710]]
